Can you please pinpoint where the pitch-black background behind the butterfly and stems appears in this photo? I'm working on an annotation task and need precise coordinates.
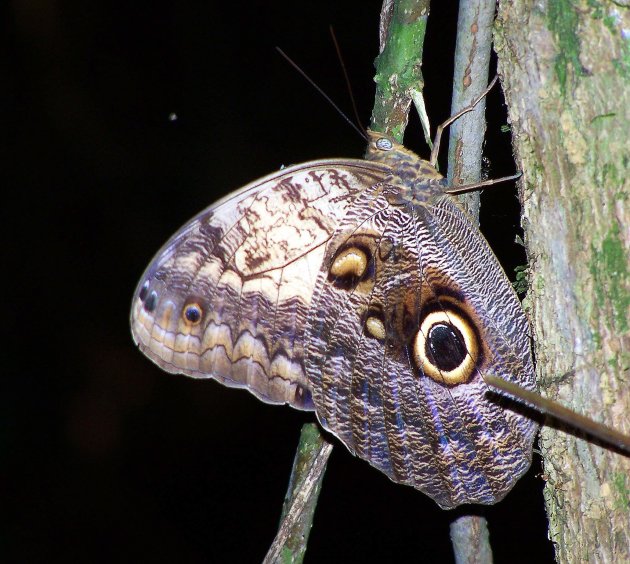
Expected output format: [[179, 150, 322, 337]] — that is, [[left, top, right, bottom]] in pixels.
[[7, 0, 552, 562]]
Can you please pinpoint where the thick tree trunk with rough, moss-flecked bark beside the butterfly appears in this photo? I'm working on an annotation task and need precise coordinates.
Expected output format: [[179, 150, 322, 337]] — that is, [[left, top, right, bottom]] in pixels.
[[496, 0, 630, 562]]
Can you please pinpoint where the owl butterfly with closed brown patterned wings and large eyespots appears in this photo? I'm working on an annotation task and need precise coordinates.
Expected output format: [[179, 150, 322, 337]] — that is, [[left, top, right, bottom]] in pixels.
[[131, 132, 538, 508]]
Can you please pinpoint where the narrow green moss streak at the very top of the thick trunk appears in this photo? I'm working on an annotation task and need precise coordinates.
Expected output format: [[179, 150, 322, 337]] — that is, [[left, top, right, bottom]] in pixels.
[[547, 0, 583, 96]]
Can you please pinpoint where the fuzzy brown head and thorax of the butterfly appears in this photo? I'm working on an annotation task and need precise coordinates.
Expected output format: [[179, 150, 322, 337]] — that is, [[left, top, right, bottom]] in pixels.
[[366, 131, 446, 205]]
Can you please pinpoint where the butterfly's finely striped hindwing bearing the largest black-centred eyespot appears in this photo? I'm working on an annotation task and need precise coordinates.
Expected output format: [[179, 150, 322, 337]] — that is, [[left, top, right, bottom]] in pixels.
[[306, 183, 537, 508]]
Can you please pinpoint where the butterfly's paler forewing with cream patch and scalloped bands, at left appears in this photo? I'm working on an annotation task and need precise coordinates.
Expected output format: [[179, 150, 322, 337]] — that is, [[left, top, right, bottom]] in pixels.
[[131, 159, 384, 409]]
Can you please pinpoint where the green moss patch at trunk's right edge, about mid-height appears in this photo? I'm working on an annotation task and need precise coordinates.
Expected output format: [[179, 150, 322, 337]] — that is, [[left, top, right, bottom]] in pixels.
[[589, 224, 630, 333]]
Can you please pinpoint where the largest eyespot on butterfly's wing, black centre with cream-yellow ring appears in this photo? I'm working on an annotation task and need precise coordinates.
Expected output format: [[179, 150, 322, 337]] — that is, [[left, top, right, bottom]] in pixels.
[[413, 309, 480, 386]]
